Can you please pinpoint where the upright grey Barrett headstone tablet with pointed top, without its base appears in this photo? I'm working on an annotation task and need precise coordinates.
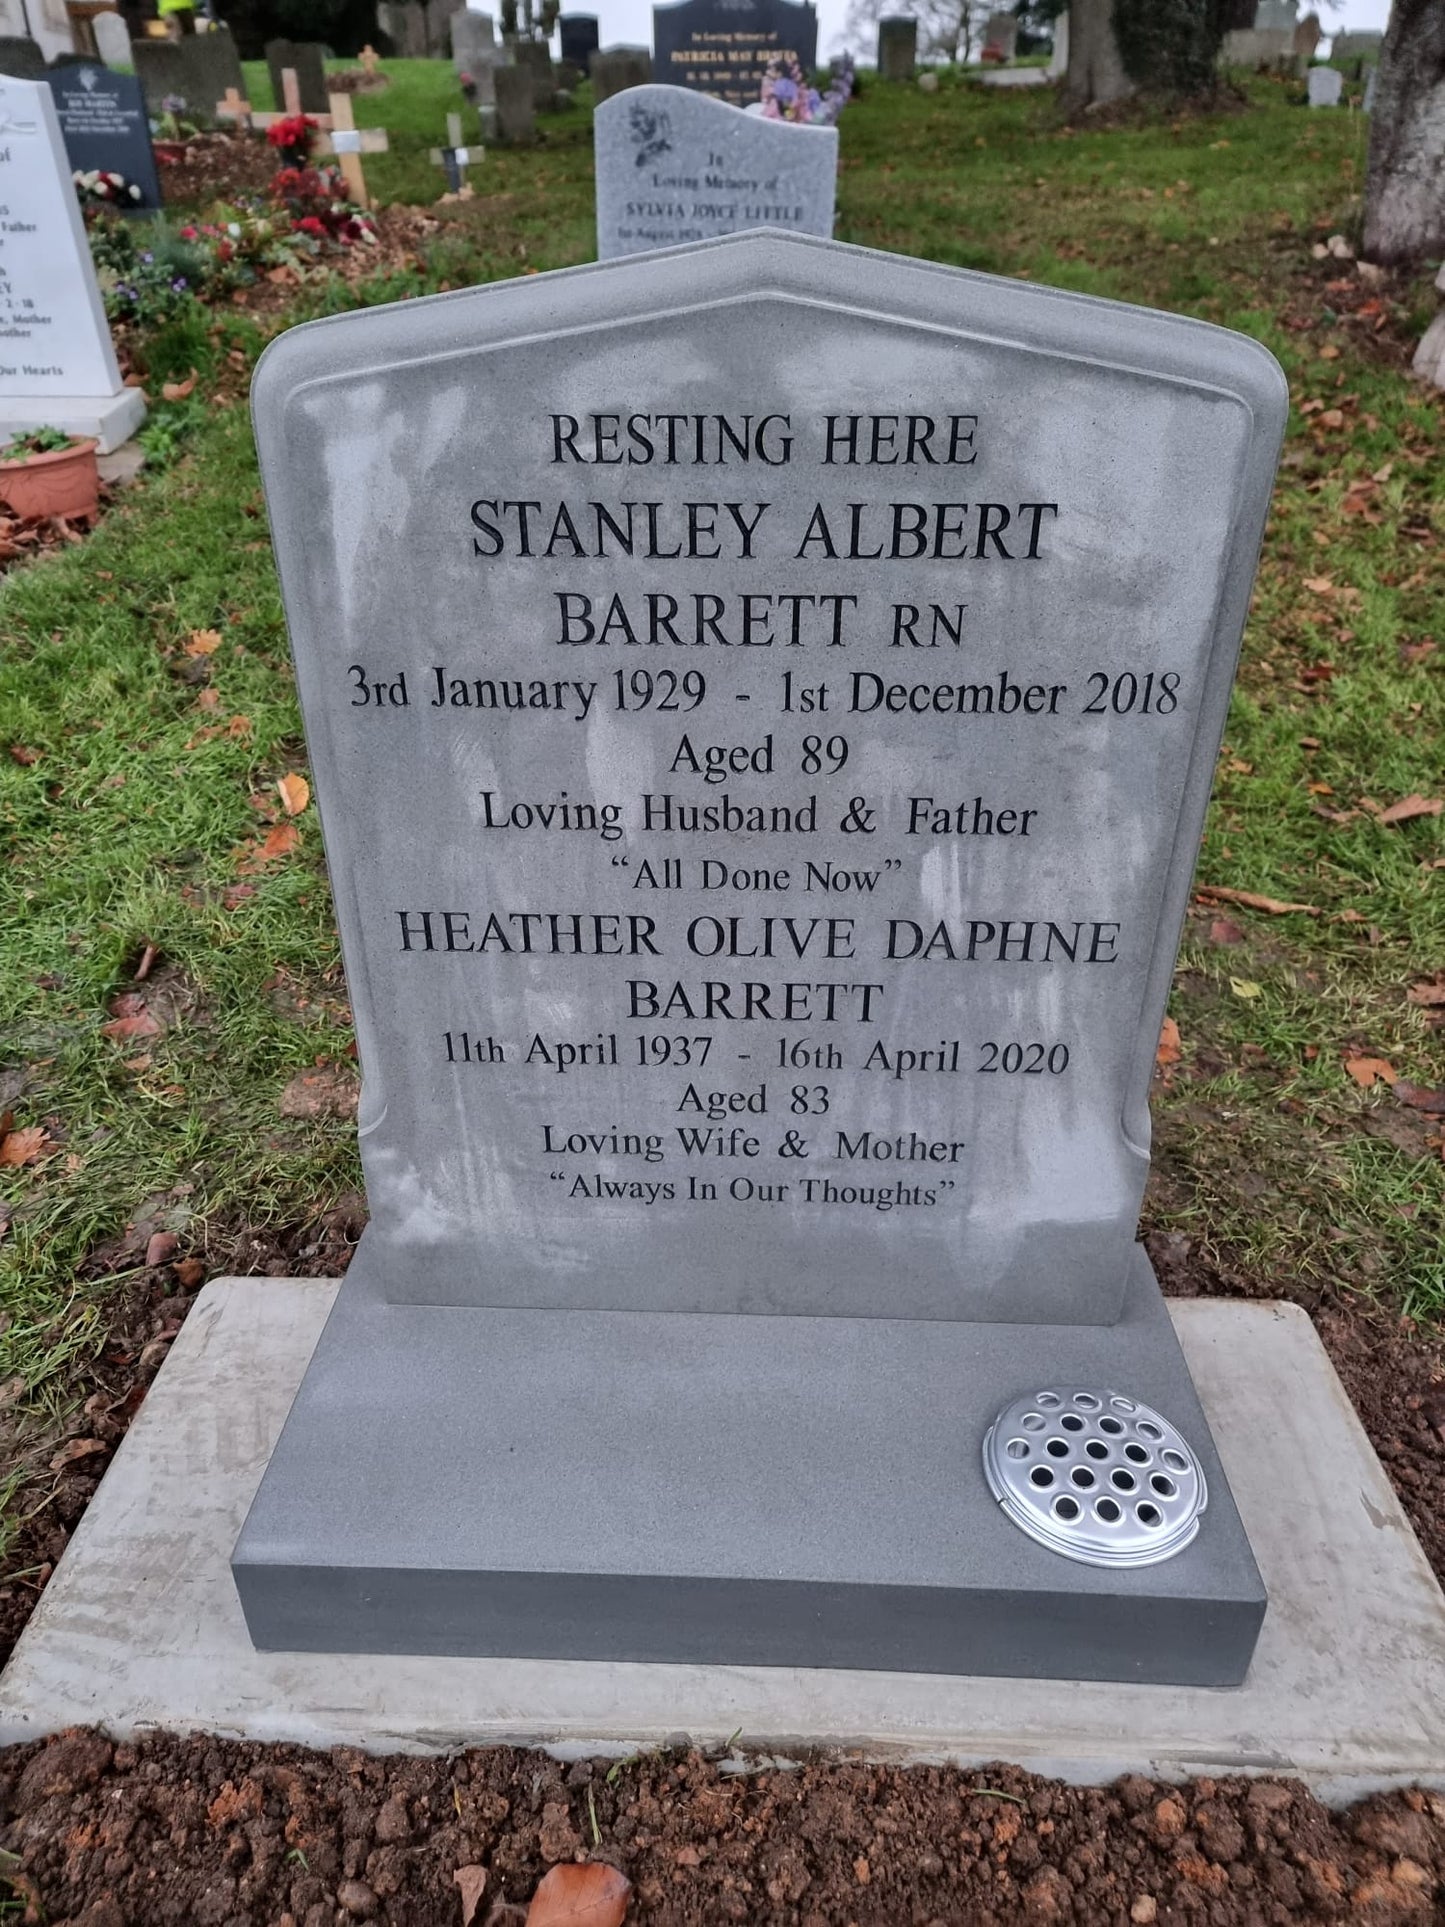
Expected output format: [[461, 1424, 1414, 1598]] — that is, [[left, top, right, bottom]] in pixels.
[[254, 233, 1287, 1324]]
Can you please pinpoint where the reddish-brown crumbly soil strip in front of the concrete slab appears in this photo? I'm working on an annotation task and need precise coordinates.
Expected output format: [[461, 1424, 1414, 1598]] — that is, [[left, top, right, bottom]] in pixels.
[[0, 1730, 1445, 1927]]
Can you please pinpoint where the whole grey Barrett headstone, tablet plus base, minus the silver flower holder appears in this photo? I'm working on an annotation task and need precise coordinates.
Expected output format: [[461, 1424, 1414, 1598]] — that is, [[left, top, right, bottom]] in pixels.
[[233, 229, 1287, 1684]]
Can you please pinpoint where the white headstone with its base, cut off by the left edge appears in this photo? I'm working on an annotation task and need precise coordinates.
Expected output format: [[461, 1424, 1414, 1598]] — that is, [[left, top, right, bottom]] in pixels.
[[0, 79, 145, 447]]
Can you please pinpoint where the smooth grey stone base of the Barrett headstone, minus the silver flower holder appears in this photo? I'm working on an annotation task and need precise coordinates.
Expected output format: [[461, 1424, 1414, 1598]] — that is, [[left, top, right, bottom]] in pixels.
[[233, 1241, 1264, 1686]]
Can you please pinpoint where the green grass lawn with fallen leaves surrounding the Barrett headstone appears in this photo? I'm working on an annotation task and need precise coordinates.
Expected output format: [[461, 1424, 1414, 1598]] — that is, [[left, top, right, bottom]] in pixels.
[[0, 79, 1445, 1580]]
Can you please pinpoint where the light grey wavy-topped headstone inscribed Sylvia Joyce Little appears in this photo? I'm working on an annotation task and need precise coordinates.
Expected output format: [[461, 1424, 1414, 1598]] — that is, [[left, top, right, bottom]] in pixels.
[[593, 87, 838, 260]]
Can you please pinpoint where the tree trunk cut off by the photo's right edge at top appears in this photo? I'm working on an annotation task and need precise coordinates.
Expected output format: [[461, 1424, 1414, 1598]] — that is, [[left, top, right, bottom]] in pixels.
[[1364, 0, 1445, 262]]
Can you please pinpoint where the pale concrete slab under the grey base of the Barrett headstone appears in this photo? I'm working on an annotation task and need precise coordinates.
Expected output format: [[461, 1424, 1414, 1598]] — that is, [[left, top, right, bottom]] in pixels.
[[0, 1280, 1445, 1802]]
